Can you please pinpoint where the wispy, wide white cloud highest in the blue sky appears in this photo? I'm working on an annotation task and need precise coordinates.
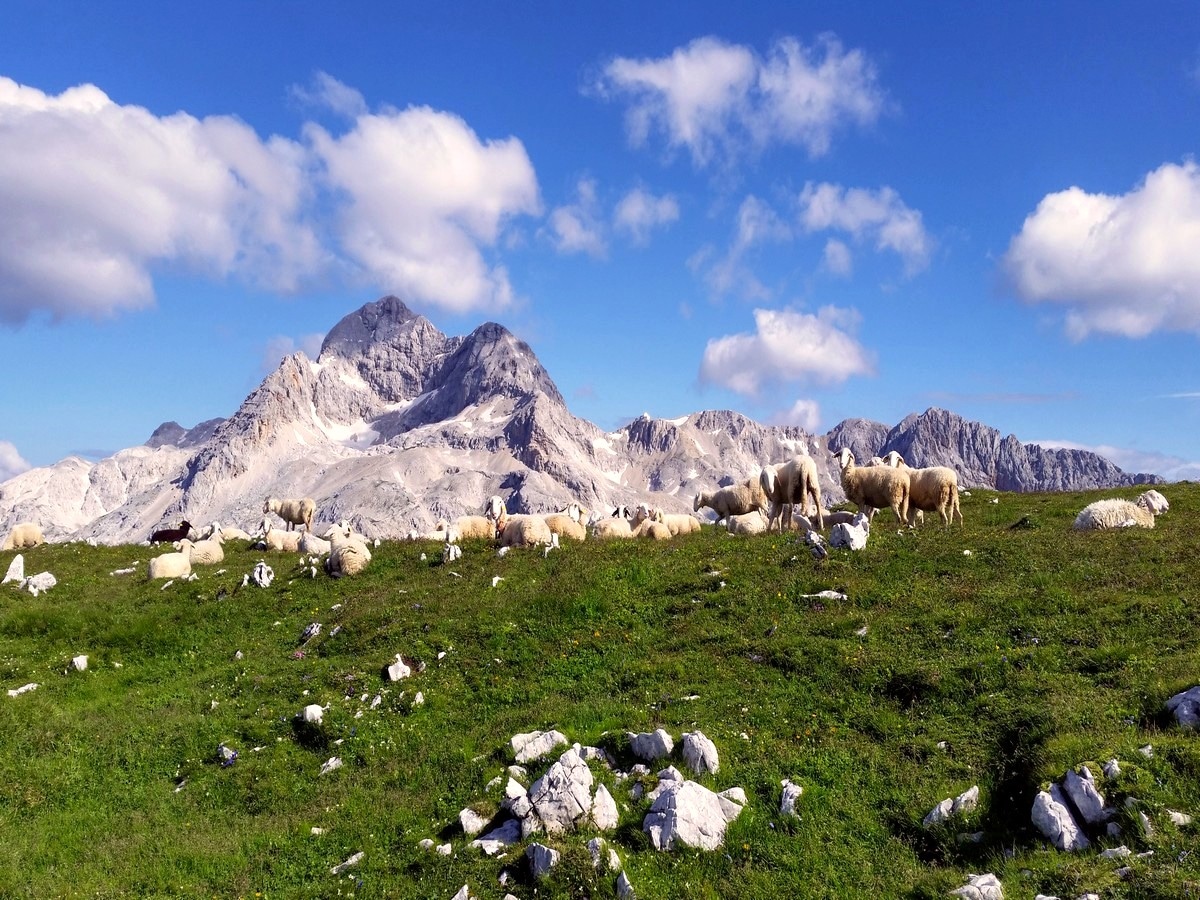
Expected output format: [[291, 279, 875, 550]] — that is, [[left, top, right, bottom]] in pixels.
[[596, 35, 886, 167]]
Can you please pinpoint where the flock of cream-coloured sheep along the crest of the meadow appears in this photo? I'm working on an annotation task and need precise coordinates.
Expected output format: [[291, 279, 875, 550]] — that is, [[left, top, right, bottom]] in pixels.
[[0, 449, 1169, 578]]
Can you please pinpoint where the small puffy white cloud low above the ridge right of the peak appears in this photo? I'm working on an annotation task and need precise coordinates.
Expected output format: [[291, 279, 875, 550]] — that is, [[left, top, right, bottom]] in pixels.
[[700, 306, 875, 396]]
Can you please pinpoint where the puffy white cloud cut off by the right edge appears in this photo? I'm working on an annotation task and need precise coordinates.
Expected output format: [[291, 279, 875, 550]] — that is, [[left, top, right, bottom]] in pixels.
[[1003, 161, 1200, 340]]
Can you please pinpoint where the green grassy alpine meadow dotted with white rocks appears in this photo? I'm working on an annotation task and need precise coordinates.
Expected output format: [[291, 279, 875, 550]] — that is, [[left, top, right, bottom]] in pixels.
[[0, 484, 1200, 900]]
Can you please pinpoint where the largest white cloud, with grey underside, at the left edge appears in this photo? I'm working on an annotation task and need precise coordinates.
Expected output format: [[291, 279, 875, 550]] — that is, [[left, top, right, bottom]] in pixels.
[[0, 77, 322, 324]]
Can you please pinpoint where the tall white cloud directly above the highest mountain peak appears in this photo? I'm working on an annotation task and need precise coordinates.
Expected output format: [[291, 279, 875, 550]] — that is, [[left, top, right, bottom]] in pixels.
[[305, 107, 541, 313]]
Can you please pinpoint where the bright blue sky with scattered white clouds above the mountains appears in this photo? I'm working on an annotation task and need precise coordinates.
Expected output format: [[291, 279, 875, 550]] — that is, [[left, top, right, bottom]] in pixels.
[[0, 0, 1200, 480]]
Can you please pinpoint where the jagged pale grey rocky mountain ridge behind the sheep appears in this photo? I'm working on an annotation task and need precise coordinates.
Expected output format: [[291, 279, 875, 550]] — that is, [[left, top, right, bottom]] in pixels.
[[0, 296, 1158, 542]]
